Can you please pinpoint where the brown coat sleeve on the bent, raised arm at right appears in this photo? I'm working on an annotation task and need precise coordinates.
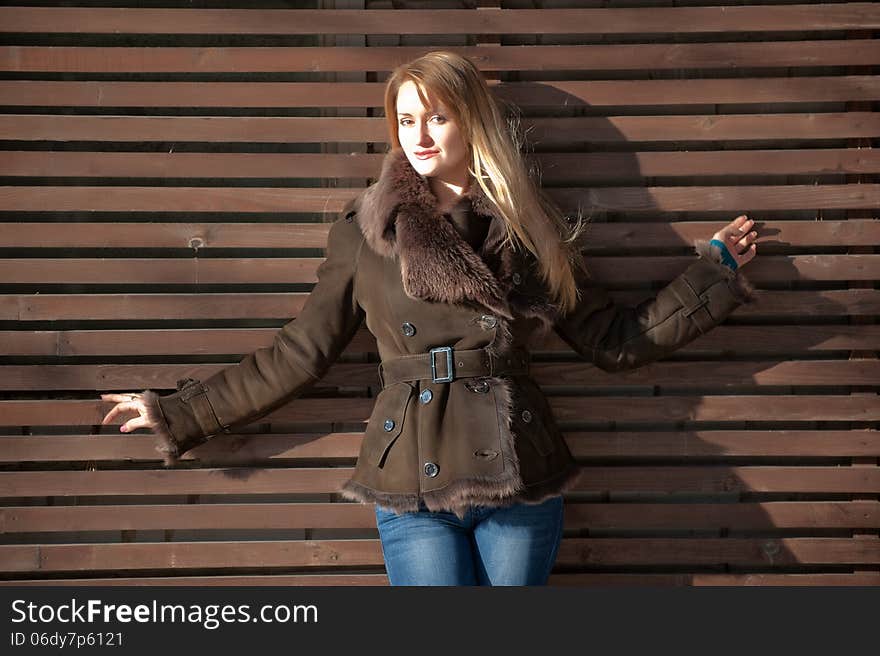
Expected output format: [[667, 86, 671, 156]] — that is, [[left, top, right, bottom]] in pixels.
[[554, 240, 755, 371]]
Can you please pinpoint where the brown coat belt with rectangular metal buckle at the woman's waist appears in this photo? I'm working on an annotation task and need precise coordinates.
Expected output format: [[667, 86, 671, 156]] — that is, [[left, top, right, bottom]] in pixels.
[[379, 346, 531, 389]]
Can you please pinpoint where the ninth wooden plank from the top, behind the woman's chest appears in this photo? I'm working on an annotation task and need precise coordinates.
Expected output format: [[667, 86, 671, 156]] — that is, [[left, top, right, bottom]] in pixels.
[[0, 292, 880, 322]]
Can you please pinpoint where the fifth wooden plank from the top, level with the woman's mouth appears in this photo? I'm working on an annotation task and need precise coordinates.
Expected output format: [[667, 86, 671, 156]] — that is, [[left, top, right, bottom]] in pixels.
[[0, 149, 880, 179]]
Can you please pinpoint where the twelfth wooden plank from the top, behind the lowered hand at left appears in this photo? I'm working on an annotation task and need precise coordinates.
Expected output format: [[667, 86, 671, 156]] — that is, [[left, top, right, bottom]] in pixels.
[[0, 392, 880, 426]]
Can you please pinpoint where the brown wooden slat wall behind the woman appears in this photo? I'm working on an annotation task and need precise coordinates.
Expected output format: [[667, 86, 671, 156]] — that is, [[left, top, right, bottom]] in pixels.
[[0, 0, 880, 586]]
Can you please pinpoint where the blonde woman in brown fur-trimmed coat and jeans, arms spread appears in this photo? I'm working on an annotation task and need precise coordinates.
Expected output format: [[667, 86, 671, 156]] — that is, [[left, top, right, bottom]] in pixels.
[[102, 52, 757, 585]]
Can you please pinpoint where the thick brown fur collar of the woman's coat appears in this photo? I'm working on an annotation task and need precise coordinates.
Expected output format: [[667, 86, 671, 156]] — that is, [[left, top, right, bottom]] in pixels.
[[355, 148, 556, 324]]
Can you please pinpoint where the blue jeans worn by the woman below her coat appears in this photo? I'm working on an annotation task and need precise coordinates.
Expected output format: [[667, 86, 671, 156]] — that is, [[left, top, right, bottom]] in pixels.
[[376, 496, 563, 585]]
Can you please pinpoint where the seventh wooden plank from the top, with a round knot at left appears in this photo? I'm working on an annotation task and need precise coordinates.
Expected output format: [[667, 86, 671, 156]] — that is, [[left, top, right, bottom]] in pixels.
[[0, 220, 880, 254]]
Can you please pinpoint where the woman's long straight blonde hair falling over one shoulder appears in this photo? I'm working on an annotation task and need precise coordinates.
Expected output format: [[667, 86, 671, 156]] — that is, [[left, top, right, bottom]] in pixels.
[[385, 50, 586, 314]]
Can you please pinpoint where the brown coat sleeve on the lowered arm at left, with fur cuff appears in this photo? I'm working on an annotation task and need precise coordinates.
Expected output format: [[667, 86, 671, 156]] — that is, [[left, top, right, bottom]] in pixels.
[[143, 205, 364, 466]]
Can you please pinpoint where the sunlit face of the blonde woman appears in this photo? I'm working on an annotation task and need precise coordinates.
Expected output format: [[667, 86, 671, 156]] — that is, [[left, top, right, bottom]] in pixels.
[[397, 80, 468, 186]]
